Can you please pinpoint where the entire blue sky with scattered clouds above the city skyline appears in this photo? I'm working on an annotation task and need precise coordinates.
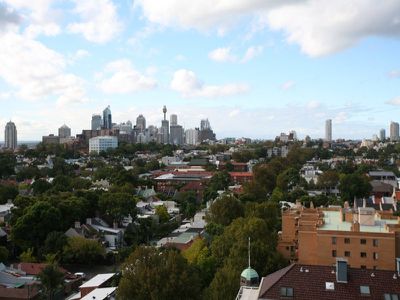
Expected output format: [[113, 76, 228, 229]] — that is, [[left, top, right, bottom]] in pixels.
[[0, 0, 400, 140]]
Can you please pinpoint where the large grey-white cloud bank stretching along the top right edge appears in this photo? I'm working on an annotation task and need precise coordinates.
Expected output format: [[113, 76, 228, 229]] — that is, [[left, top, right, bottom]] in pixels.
[[135, 0, 400, 57]]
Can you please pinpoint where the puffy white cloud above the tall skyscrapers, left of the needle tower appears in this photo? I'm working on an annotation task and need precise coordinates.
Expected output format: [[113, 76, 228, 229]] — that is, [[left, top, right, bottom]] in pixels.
[[96, 59, 157, 94]]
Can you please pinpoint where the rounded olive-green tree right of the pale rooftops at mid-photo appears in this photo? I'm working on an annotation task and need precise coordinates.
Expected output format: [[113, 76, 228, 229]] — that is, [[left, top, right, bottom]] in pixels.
[[207, 195, 244, 226]]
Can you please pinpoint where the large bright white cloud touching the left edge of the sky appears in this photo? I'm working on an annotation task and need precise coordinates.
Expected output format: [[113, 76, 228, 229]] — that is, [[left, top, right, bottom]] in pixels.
[[0, 32, 85, 103]]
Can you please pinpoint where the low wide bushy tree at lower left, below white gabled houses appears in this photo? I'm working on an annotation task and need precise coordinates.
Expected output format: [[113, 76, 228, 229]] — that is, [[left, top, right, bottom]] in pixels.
[[63, 237, 106, 265]]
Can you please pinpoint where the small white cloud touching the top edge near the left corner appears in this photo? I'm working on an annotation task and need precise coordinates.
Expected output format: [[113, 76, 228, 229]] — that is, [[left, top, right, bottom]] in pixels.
[[4, 0, 61, 38]]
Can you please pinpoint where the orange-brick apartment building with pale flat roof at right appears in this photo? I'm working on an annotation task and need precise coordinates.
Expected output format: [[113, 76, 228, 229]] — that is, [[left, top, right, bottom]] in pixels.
[[278, 204, 400, 270]]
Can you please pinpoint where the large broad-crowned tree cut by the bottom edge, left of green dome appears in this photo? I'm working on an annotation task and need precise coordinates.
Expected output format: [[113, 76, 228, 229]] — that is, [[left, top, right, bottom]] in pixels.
[[117, 247, 201, 300]]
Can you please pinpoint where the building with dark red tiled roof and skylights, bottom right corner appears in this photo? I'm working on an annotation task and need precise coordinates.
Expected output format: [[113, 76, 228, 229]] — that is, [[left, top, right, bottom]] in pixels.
[[236, 259, 400, 300]]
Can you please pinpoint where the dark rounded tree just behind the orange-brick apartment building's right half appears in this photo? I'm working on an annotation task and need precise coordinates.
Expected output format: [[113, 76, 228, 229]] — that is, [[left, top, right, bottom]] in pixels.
[[339, 173, 372, 201]]
